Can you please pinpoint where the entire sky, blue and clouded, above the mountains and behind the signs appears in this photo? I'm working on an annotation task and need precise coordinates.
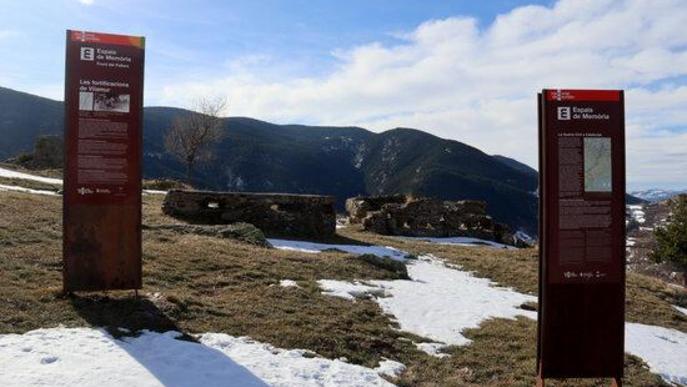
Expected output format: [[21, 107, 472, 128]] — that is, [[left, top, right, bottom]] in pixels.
[[0, 0, 687, 189]]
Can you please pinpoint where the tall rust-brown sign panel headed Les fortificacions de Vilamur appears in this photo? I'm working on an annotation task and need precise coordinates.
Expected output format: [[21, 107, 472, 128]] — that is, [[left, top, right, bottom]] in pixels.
[[63, 31, 144, 292]]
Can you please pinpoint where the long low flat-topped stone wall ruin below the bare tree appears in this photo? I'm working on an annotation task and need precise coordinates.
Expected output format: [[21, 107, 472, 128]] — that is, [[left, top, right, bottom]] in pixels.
[[162, 190, 336, 239]]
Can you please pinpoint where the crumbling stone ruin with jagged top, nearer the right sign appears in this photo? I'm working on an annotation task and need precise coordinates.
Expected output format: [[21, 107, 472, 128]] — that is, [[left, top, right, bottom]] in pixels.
[[346, 196, 513, 244]]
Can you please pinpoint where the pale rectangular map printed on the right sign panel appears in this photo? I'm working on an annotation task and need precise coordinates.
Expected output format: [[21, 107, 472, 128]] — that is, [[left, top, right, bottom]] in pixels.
[[584, 137, 612, 192]]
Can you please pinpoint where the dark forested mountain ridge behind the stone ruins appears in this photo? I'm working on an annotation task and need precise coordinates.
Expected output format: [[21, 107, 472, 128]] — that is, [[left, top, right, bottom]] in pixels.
[[0, 88, 537, 235]]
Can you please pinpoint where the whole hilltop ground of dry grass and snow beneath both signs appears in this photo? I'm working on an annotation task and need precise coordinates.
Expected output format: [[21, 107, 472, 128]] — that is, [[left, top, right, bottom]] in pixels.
[[0, 171, 687, 386]]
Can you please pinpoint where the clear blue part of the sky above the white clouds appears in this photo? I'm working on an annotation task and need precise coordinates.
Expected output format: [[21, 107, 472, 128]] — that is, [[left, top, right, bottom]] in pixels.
[[0, 0, 548, 100]]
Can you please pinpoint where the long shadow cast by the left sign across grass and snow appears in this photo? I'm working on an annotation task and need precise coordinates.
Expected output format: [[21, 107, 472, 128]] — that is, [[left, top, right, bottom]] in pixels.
[[69, 295, 267, 386]]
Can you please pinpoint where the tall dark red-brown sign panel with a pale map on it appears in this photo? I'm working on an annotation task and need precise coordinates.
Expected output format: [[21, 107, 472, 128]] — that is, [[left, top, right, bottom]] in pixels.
[[537, 90, 625, 384]]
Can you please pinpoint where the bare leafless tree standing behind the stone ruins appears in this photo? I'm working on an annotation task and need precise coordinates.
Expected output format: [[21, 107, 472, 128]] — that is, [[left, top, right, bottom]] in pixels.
[[165, 98, 227, 184]]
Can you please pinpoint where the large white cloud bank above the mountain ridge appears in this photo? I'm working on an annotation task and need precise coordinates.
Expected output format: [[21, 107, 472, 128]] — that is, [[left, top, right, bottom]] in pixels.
[[158, 0, 687, 186]]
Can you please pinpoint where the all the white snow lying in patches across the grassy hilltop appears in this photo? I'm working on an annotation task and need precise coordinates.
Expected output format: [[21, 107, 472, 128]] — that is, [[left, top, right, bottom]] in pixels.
[[0, 189, 687, 387]]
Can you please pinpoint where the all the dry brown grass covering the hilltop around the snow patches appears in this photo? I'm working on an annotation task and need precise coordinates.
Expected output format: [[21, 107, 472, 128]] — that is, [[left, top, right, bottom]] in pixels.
[[0, 192, 685, 386]]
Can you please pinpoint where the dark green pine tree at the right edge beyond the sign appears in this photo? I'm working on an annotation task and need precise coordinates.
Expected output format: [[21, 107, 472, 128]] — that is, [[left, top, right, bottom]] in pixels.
[[651, 194, 687, 285]]
